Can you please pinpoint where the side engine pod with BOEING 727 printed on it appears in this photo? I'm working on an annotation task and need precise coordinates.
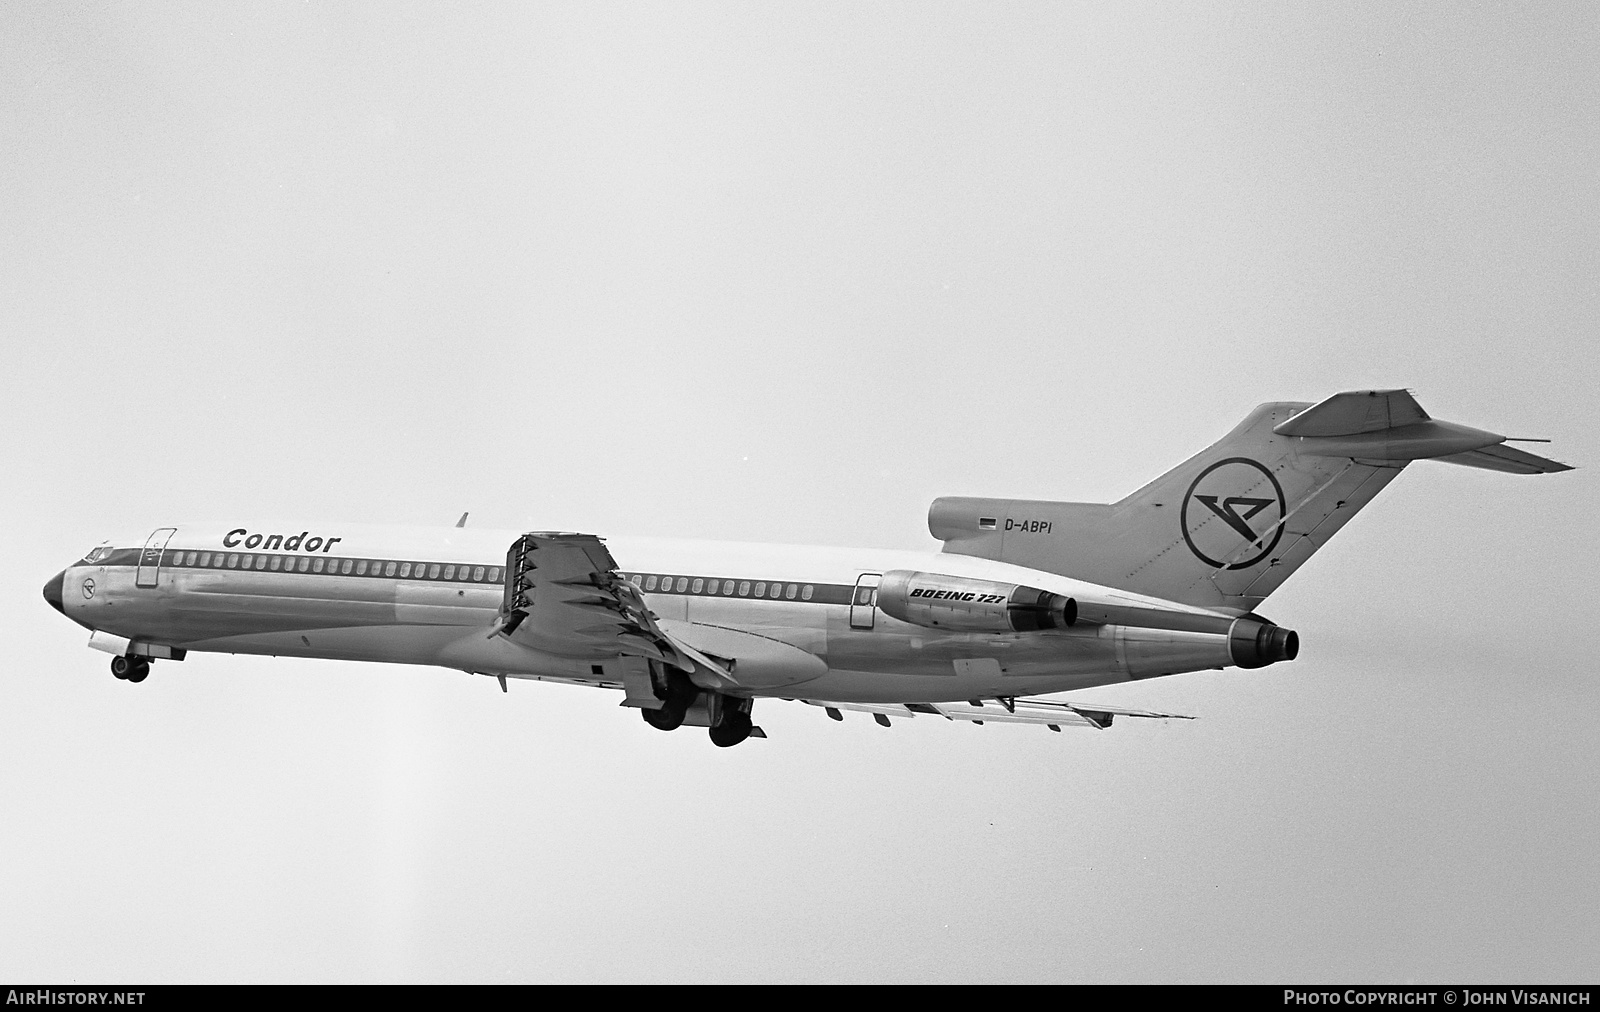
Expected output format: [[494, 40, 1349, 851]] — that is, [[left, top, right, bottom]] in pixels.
[[878, 570, 1078, 633]]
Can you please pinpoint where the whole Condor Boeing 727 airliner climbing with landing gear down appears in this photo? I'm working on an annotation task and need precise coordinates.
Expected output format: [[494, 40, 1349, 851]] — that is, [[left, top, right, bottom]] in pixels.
[[45, 389, 1571, 748]]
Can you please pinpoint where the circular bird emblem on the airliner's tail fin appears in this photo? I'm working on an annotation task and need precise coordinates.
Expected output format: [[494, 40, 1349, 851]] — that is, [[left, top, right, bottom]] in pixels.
[[1179, 456, 1285, 570]]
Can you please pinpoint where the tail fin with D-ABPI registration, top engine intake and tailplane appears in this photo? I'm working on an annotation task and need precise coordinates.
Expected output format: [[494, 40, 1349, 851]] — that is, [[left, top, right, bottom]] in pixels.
[[928, 391, 1568, 612]]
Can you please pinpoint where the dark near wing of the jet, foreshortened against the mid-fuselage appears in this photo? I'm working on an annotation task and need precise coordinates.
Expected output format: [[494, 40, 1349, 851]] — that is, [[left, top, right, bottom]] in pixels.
[[490, 532, 728, 677]]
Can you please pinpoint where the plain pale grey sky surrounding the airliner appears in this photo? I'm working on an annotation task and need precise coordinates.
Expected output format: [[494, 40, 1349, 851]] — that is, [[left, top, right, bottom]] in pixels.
[[0, 2, 1600, 982]]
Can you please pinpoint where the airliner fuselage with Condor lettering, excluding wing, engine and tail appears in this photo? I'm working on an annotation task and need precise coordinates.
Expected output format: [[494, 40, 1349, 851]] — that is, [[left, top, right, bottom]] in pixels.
[[59, 524, 1234, 703]]
